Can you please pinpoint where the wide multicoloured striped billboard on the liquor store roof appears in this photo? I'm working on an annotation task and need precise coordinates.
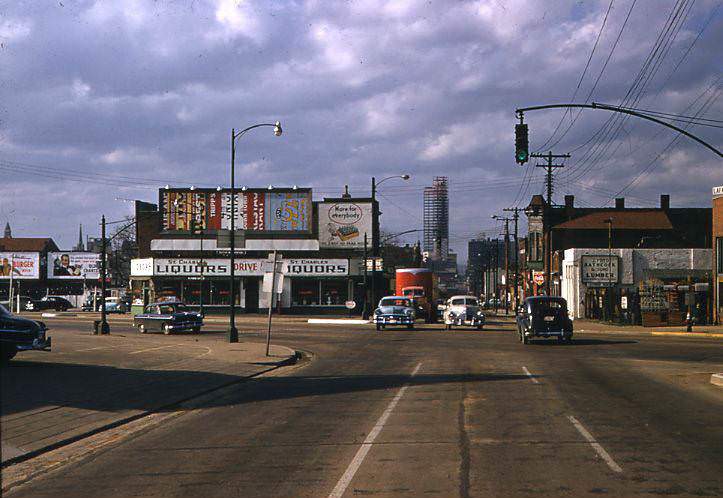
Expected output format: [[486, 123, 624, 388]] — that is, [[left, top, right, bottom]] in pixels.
[[159, 189, 312, 232]]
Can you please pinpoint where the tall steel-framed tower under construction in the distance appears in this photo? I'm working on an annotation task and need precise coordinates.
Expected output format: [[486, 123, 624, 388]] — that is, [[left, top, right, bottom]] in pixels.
[[424, 176, 449, 260]]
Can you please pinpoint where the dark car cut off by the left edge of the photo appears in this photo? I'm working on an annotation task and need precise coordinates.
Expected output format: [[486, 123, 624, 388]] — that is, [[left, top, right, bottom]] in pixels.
[[0, 305, 51, 363]]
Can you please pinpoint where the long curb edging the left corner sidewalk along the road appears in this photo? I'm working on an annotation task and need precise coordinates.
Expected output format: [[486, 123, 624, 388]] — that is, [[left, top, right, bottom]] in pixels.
[[0, 346, 305, 468]]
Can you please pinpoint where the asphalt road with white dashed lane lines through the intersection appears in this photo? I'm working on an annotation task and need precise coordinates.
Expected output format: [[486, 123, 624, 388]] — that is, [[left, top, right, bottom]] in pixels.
[[5, 323, 723, 498]]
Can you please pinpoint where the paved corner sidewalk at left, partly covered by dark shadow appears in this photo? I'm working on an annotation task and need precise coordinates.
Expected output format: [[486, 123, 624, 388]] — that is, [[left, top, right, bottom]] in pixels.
[[0, 331, 296, 466]]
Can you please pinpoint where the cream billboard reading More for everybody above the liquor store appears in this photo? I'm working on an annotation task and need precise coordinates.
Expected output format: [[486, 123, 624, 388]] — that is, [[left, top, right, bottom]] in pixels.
[[319, 202, 372, 249]]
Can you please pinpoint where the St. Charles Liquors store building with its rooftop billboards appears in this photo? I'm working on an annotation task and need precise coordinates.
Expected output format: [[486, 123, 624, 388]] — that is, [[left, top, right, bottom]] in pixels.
[[131, 188, 377, 313]]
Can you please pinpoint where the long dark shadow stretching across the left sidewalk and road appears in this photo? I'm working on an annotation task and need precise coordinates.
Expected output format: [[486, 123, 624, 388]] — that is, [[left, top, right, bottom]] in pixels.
[[1, 361, 527, 416]]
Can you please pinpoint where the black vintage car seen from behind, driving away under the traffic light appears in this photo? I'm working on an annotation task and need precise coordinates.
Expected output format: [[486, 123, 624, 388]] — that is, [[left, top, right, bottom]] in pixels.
[[516, 296, 572, 344]]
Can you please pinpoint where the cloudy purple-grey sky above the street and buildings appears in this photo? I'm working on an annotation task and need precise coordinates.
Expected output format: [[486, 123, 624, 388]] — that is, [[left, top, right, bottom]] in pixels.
[[0, 0, 723, 262]]
